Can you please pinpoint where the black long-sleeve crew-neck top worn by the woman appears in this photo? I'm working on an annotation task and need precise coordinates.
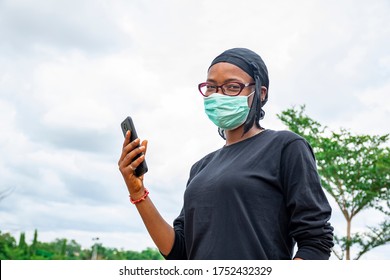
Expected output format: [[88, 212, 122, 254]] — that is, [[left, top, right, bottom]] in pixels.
[[166, 130, 333, 260]]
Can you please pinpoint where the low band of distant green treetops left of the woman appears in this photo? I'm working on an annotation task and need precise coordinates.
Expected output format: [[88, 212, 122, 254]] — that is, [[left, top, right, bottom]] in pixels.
[[0, 230, 163, 260]]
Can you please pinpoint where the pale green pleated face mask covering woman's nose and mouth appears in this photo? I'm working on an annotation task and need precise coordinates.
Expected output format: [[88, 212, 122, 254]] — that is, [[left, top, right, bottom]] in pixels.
[[204, 92, 254, 130]]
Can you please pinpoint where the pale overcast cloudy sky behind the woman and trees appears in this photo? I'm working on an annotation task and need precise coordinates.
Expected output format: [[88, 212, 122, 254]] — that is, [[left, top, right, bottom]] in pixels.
[[0, 0, 390, 259]]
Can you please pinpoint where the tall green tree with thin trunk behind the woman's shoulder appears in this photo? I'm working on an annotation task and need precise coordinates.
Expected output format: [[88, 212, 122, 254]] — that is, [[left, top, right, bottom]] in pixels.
[[278, 106, 390, 260]]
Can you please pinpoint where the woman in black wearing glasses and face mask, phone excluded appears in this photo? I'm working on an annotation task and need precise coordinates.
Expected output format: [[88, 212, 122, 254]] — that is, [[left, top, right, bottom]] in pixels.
[[118, 48, 333, 260]]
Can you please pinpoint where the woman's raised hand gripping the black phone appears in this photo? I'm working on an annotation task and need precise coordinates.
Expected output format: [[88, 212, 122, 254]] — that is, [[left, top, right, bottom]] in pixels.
[[118, 131, 148, 200]]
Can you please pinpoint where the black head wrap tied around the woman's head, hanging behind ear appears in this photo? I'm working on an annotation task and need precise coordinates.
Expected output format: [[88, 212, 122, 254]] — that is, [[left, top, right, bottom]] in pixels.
[[209, 48, 269, 138]]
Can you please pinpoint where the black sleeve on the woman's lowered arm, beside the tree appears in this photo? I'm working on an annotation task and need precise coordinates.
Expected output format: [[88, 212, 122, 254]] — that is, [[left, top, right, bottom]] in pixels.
[[280, 139, 334, 260]]
